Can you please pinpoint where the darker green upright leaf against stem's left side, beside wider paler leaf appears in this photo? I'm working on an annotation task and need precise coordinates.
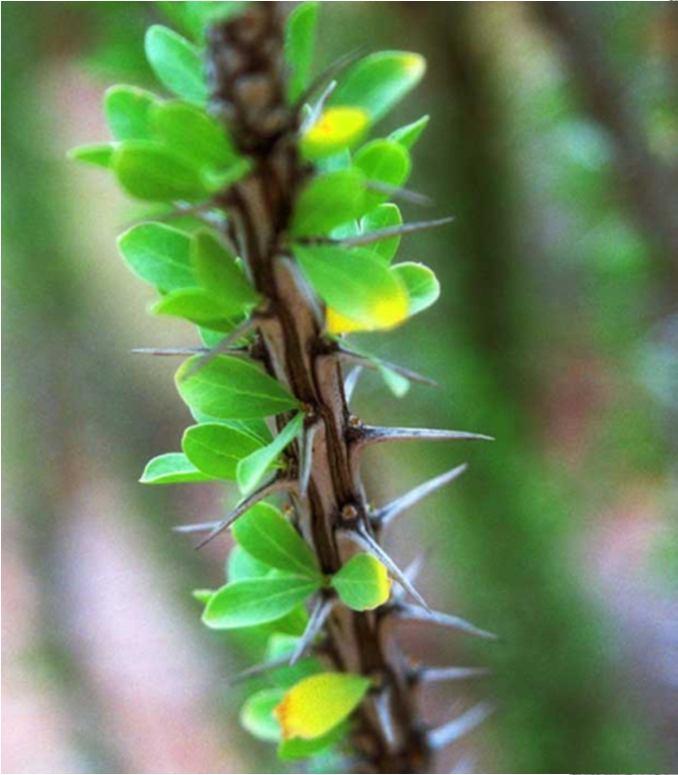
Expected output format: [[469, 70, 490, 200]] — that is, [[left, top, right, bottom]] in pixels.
[[192, 232, 259, 316]]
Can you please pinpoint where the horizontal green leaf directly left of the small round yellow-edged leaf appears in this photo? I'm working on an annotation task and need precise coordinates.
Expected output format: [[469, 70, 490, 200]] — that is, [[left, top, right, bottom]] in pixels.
[[202, 576, 320, 630]]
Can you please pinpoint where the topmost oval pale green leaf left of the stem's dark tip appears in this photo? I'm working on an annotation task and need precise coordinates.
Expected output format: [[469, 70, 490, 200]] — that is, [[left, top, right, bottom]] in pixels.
[[145, 24, 208, 105]]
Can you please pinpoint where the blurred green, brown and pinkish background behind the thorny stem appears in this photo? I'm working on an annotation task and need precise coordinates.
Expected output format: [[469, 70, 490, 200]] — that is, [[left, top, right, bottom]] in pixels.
[[2, 2, 678, 773]]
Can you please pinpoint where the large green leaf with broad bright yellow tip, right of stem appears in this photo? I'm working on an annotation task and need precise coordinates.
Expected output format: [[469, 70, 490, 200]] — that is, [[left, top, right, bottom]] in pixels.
[[294, 245, 408, 333]]
